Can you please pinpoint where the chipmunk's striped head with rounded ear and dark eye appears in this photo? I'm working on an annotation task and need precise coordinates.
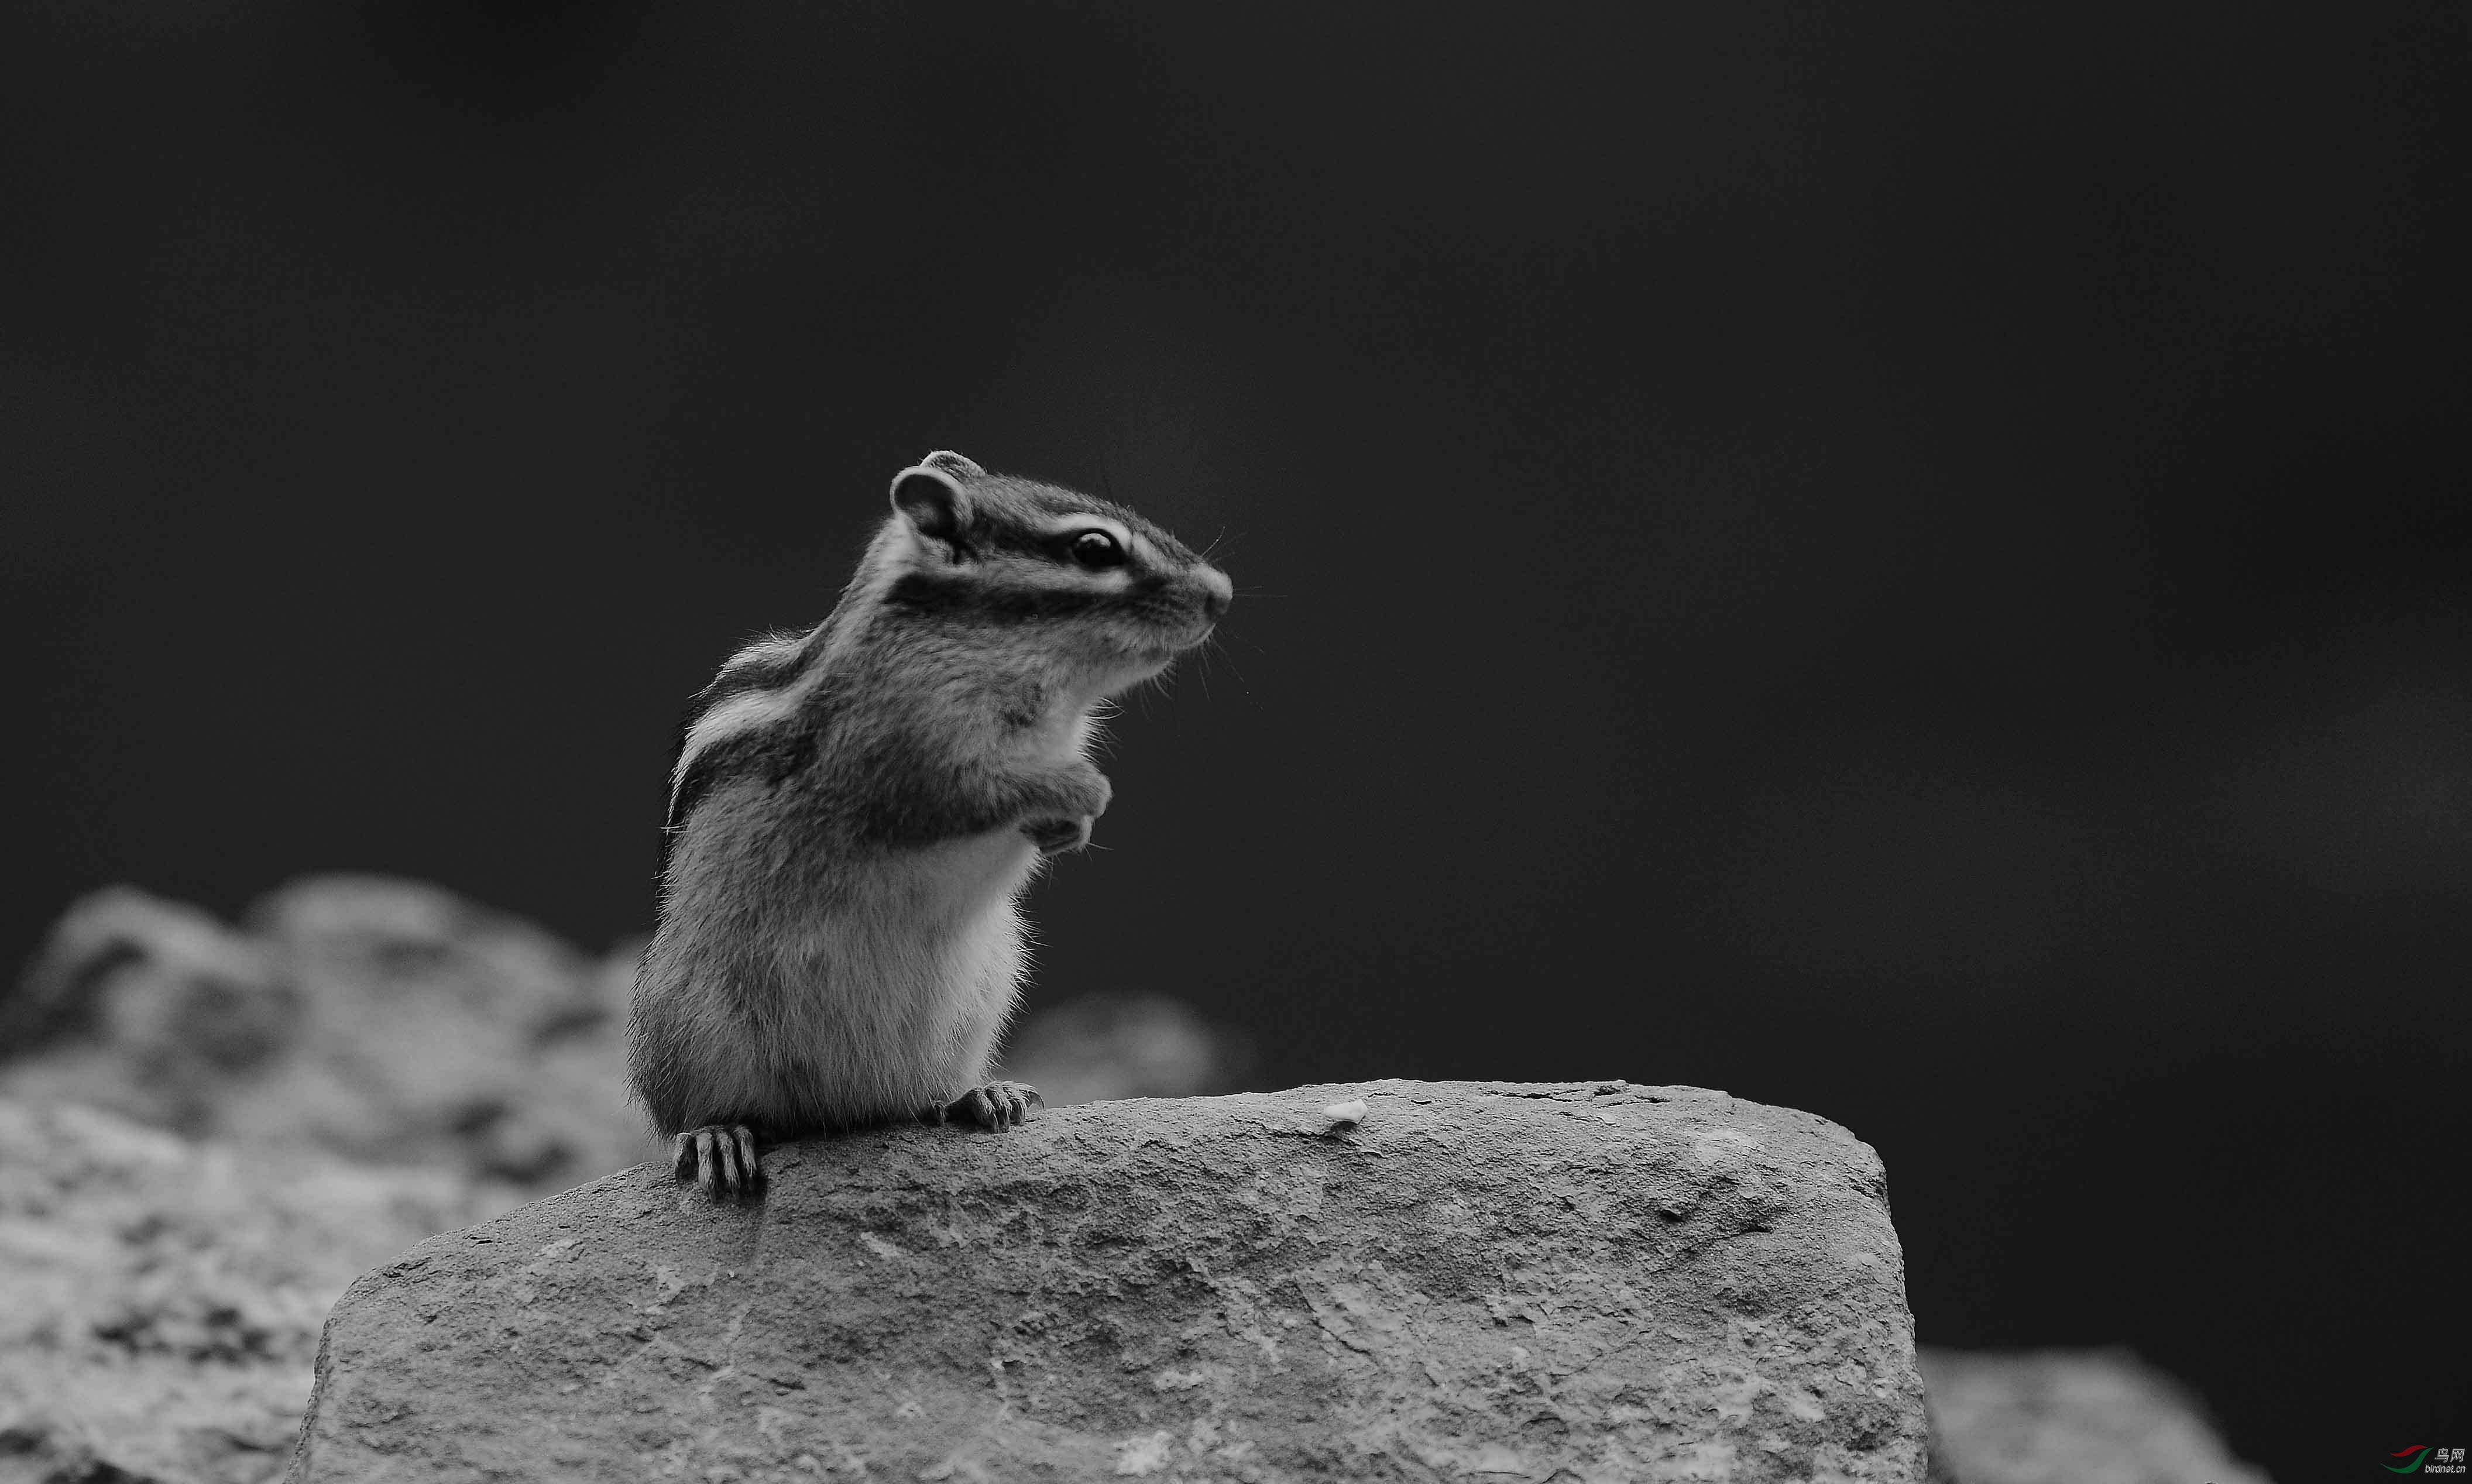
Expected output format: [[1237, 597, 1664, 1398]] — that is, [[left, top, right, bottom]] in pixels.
[[878, 452, 1234, 690]]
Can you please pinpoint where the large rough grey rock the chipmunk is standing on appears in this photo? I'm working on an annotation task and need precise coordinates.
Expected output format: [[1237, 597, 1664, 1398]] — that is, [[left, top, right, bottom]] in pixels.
[[289, 1081, 1923, 1482]]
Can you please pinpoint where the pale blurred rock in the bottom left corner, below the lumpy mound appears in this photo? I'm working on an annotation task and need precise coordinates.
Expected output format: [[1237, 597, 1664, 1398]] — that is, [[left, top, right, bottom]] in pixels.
[[0, 1098, 487, 1484]]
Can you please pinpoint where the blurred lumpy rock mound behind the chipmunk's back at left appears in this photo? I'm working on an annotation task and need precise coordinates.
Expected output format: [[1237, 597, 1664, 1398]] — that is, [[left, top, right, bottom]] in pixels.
[[0, 878, 653, 1204]]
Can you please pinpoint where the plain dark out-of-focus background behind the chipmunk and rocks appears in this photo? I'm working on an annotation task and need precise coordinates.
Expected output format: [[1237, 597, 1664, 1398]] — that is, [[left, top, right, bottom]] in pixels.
[[0, 0, 2472, 1484]]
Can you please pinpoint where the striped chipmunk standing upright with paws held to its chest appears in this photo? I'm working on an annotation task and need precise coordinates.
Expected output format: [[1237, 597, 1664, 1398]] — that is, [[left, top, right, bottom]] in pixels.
[[628, 452, 1234, 1197]]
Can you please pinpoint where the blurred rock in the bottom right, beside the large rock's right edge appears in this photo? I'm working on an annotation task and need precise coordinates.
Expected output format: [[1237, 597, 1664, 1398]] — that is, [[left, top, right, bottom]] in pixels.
[[1918, 1348, 2267, 1484]]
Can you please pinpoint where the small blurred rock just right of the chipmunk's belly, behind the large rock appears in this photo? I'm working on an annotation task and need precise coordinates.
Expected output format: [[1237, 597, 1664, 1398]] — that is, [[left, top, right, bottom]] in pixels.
[[1004, 994, 1254, 1108]]
